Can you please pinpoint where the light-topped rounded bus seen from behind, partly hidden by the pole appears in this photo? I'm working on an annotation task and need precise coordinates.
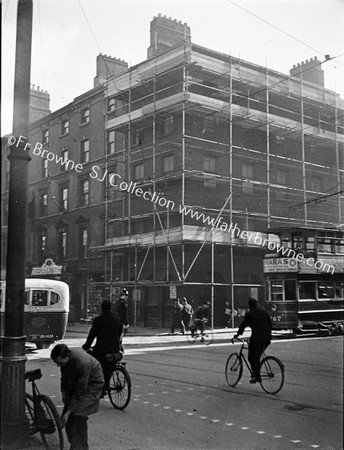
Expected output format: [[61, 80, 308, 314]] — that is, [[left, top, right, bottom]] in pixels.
[[0, 278, 69, 349]]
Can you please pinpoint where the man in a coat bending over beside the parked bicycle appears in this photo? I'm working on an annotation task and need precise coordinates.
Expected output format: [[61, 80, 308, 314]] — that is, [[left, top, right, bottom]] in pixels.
[[50, 344, 104, 450]]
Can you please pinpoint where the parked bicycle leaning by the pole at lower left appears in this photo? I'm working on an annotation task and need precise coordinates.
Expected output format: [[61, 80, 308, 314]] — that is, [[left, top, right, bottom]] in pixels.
[[25, 369, 64, 450]]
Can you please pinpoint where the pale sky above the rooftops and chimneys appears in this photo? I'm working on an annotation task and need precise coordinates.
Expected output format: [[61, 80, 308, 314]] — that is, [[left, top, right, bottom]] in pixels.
[[1, 0, 344, 135]]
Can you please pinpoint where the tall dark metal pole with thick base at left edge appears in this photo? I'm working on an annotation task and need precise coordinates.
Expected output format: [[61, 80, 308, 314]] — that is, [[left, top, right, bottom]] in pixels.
[[0, 0, 33, 449]]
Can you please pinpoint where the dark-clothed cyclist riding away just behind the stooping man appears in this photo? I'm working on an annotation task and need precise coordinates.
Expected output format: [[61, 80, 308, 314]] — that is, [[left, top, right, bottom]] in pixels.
[[82, 300, 123, 394]]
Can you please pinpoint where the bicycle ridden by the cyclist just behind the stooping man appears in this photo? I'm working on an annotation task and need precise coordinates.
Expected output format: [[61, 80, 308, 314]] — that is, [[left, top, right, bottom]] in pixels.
[[87, 348, 131, 409]]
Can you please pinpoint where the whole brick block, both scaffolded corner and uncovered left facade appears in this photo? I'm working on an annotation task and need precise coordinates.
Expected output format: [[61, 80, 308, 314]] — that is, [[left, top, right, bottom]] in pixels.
[[2, 15, 344, 327]]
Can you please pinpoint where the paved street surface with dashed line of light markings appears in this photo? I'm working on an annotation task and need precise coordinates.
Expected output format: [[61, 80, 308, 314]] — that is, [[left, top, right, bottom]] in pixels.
[[27, 336, 343, 450]]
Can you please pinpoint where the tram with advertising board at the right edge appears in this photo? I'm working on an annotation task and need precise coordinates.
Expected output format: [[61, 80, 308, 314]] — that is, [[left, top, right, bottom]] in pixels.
[[263, 227, 344, 333]]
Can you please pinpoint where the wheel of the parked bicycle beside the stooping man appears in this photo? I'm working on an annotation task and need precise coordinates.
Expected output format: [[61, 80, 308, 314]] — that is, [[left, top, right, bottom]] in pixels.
[[34, 394, 64, 450]]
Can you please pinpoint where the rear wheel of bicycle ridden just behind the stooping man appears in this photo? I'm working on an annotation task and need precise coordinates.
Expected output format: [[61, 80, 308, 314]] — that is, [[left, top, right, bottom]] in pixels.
[[108, 366, 131, 409]]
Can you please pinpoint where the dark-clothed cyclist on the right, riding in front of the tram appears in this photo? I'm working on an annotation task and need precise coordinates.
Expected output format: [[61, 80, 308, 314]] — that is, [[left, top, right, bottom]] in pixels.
[[234, 298, 272, 383]]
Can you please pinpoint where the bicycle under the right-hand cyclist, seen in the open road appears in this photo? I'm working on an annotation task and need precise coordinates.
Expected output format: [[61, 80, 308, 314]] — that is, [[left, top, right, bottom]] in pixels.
[[225, 338, 284, 394]]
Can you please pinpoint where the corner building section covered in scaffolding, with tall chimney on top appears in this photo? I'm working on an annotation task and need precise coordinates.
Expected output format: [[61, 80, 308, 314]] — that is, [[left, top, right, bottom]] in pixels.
[[89, 16, 344, 326]]
